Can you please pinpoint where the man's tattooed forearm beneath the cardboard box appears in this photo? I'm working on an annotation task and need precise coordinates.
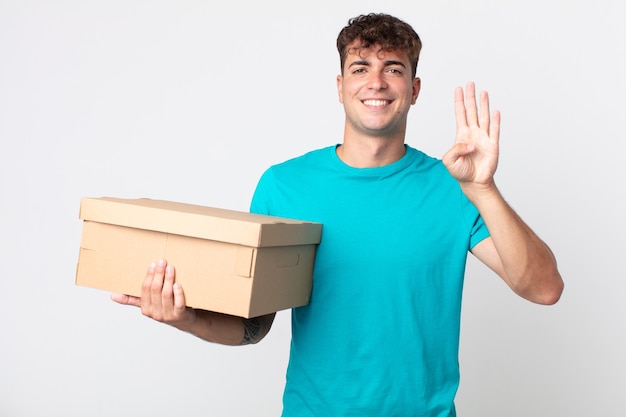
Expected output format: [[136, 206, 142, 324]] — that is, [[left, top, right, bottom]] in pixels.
[[175, 310, 275, 346]]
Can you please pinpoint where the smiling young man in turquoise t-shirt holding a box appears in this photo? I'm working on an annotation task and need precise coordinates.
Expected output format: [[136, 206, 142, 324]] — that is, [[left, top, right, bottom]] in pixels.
[[113, 14, 563, 417]]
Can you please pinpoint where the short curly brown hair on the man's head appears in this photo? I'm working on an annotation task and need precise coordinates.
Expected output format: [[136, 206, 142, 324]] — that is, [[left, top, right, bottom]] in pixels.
[[337, 13, 422, 77]]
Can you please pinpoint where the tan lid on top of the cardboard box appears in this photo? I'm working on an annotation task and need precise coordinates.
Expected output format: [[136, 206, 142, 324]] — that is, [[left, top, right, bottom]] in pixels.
[[80, 197, 322, 247]]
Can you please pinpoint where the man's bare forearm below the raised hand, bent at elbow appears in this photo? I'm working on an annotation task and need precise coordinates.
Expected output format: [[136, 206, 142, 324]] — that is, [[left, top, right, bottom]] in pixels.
[[464, 185, 563, 304]]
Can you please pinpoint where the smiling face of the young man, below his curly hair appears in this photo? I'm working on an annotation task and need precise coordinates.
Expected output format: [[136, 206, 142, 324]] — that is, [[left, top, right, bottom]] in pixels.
[[337, 44, 420, 137]]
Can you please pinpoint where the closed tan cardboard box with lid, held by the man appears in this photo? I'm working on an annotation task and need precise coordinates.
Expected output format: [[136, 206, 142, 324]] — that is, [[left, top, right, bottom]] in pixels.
[[76, 197, 322, 317]]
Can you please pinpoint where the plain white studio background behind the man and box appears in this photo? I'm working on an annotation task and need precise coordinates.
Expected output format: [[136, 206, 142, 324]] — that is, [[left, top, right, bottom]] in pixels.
[[0, 0, 626, 417]]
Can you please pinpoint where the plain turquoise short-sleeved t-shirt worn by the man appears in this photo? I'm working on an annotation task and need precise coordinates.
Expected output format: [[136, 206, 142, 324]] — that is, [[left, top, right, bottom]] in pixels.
[[251, 146, 489, 417]]
